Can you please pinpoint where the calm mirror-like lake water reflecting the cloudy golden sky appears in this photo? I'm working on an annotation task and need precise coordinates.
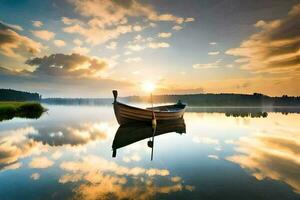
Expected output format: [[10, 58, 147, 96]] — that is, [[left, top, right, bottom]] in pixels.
[[0, 105, 300, 200]]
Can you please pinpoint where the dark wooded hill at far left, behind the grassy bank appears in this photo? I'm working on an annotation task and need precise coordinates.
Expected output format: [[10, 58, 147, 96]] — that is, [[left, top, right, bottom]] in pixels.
[[0, 89, 42, 101]]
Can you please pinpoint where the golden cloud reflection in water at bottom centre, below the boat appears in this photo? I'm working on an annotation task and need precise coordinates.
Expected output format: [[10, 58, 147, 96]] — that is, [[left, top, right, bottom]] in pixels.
[[59, 155, 194, 200]]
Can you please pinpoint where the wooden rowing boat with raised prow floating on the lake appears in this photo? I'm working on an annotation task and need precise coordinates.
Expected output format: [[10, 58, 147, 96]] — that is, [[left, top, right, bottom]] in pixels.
[[113, 90, 186, 125]]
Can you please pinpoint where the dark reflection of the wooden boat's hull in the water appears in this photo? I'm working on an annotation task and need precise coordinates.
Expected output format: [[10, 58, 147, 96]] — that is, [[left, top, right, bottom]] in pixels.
[[112, 118, 186, 157]]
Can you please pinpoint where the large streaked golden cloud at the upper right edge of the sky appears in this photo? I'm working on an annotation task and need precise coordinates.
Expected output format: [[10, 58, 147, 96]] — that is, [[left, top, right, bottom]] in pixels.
[[226, 4, 300, 75]]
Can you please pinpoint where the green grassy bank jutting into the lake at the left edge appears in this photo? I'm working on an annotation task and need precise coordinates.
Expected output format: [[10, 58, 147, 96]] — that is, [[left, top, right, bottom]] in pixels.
[[0, 101, 46, 121]]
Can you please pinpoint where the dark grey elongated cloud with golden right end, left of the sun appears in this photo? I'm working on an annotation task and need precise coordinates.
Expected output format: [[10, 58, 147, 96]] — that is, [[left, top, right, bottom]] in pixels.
[[26, 53, 108, 77]]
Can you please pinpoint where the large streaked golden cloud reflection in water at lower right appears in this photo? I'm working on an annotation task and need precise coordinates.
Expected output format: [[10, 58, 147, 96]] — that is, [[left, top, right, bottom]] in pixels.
[[226, 131, 300, 193]]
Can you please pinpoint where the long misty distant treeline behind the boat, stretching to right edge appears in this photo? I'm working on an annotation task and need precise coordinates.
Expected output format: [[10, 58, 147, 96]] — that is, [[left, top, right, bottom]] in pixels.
[[42, 93, 300, 107]]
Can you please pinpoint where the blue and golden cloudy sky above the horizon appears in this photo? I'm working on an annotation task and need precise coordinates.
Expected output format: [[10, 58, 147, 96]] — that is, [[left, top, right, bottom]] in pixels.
[[0, 0, 300, 97]]
